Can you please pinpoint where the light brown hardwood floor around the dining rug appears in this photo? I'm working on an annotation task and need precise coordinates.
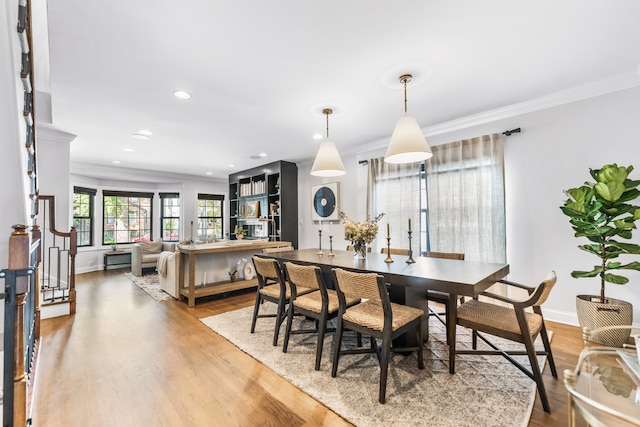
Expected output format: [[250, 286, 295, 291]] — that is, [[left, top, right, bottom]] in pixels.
[[33, 270, 582, 427]]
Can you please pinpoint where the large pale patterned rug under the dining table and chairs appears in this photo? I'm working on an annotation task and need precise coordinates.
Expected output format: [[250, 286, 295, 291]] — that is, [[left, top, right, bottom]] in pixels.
[[200, 304, 543, 427]]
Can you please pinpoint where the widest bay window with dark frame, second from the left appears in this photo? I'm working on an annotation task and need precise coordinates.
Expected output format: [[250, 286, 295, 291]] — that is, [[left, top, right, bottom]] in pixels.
[[102, 191, 153, 245]]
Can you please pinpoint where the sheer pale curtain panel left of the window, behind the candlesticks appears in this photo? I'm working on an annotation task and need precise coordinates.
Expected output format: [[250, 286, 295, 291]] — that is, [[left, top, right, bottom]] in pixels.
[[367, 157, 421, 254]]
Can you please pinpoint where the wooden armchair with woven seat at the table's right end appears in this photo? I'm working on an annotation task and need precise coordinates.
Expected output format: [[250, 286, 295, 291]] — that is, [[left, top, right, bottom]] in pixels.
[[449, 272, 558, 412]]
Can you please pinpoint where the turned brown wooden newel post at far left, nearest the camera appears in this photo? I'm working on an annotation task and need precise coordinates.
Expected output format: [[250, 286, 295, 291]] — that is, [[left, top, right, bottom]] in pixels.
[[5, 224, 30, 426]]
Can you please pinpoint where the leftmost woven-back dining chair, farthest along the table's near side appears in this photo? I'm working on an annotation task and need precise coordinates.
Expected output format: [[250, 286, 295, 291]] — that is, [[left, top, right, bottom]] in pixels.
[[251, 256, 291, 346]]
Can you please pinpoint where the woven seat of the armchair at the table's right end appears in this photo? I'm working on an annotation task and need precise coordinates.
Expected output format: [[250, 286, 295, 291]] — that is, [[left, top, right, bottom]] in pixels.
[[458, 300, 542, 336]]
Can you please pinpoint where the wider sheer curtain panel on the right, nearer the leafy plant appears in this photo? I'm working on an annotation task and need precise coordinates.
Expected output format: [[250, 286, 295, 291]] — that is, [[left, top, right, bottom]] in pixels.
[[425, 134, 506, 263]]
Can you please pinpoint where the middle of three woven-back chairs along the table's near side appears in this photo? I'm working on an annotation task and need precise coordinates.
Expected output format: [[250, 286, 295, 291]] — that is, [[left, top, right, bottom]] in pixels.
[[282, 262, 360, 371]]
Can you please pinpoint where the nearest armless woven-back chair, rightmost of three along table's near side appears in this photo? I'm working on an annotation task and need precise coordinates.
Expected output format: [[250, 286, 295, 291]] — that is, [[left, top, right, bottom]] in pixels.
[[331, 268, 424, 403]]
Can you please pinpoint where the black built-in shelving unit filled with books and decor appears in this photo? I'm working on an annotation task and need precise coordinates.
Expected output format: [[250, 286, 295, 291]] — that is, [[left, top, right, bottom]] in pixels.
[[229, 161, 298, 248]]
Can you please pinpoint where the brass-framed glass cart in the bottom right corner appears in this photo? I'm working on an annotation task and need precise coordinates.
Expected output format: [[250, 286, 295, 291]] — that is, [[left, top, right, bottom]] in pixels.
[[564, 347, 640, 426]]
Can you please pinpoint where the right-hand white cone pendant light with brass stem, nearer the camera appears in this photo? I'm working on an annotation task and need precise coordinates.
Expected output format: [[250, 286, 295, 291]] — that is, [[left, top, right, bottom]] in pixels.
[[384, 74, 433, 163]]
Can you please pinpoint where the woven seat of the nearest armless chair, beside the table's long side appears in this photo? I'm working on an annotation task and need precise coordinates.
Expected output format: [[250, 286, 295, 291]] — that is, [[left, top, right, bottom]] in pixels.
[[342, 300, 424, 331]]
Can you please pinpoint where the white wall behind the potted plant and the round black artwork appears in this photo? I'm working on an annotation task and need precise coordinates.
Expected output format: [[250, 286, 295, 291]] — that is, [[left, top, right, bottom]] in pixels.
[[298, 87, 640, 325]]
